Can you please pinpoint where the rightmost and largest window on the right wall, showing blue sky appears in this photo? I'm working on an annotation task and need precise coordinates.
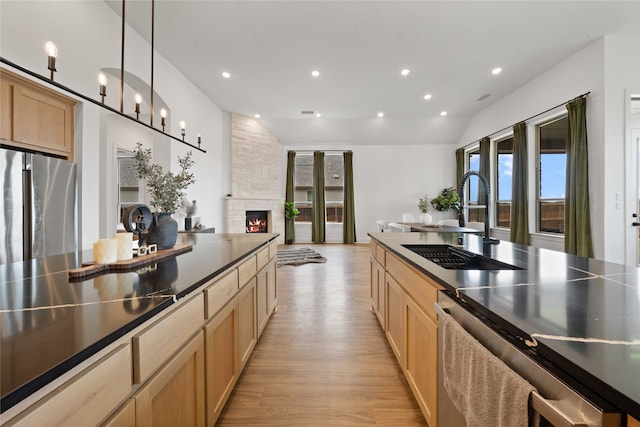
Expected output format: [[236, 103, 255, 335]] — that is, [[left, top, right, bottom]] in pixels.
[[537, 116, 569, 234]]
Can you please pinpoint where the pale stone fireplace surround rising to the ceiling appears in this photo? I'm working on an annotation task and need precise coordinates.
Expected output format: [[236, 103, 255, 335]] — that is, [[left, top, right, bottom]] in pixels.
[[224, 113, 284, 244]]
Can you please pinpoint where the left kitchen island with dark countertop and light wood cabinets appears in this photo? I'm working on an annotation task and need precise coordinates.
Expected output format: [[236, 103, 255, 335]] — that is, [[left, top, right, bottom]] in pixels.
[[0, 233, 278, 425]]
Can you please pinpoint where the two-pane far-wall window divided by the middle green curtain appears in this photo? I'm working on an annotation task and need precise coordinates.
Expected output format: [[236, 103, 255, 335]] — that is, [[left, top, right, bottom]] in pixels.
[[294, 153, 344, 223]]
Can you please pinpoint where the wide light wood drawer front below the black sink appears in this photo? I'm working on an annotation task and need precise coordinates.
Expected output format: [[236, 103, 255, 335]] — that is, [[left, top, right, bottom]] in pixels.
[[386, 254, 442, 323]]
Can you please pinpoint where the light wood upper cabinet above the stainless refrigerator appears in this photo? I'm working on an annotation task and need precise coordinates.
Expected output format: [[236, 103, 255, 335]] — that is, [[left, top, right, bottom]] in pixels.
[[0, 69, 76, 160]]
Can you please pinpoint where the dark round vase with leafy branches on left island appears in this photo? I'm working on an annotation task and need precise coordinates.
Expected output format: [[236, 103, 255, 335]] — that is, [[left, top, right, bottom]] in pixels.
[[134, 142, 196, 249]]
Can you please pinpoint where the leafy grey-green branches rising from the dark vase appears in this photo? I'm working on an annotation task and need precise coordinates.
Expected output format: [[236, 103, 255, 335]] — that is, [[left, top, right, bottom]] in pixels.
[[134, 142, 196, 213]]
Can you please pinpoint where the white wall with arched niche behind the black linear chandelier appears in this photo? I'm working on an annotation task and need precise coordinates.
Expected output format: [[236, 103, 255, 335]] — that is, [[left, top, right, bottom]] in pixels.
[[0, 1, 228, 249]]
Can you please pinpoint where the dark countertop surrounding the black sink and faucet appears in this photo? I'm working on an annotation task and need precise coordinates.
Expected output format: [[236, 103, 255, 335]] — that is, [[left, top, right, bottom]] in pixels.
[[370, 233, 640, 419]]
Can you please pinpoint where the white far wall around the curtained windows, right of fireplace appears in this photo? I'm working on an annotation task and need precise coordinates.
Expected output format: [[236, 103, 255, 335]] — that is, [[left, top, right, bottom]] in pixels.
[[282, 144, 455, 243]]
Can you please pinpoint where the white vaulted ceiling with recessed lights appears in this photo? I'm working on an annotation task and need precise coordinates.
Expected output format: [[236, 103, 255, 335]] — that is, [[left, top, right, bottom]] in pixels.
[[106, 0, 640, 146]]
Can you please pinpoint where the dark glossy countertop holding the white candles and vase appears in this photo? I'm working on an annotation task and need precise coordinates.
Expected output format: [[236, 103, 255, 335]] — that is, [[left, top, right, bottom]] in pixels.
[[0, 233, 278, 411]]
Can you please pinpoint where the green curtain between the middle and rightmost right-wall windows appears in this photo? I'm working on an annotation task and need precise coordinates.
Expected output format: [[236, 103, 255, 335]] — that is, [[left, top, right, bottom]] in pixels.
[[509, 122, 529, 245]]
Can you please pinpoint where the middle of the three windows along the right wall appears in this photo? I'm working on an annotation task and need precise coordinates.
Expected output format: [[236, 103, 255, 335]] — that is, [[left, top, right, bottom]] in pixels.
[[495, 137, 513, 228]]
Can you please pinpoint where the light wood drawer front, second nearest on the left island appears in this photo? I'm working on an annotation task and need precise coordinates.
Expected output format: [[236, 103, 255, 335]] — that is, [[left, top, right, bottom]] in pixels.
[[133, 295, 204, 384]]
